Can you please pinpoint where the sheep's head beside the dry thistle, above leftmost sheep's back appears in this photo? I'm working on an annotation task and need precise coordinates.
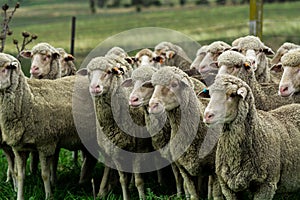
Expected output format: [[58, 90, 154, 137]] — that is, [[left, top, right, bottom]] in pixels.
[[20, 42, 61, 79]]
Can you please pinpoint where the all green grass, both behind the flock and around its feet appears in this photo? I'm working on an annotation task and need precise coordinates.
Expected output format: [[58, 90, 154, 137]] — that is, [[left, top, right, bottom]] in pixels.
[[0, 0, 300, 200]]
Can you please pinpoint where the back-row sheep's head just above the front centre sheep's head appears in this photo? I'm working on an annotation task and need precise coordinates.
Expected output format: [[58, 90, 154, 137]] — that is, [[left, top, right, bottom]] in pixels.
[[154, 42, 192, 70]]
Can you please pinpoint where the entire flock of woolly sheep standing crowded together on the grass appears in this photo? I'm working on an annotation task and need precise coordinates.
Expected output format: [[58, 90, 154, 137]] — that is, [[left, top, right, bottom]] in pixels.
[[0, 36, 300, 200]]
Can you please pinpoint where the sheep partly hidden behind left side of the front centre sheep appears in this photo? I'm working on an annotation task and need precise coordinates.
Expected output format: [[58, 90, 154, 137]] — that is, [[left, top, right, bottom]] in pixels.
[[122, 66, 183, 196]]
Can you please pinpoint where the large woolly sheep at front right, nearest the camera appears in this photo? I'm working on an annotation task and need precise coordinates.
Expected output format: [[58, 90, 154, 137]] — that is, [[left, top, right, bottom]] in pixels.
[[204, 74, 300, 200]]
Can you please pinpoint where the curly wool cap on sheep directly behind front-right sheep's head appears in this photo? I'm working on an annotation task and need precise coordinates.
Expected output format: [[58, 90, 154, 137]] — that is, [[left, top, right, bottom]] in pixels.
[[218, 51, 246, 66]]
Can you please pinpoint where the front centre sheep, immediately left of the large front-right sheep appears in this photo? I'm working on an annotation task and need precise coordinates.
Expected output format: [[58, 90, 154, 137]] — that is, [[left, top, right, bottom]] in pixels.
[[148, 66, 220, 199]]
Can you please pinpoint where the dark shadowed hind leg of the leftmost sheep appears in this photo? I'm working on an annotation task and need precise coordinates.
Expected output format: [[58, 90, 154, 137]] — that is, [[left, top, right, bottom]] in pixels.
[[79, 152, 97, 184]]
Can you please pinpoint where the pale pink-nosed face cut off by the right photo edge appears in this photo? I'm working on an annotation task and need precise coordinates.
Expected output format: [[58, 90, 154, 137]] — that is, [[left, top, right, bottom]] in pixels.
[[278, 66, 300, 97]]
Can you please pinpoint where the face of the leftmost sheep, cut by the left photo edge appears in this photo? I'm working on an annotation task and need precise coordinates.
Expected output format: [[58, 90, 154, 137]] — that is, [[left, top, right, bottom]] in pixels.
[[0, 62, 19, 90]]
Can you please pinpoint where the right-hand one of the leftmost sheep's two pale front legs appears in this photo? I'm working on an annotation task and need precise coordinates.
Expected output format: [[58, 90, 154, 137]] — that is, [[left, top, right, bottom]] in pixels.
[[39, 153, 53, 199]]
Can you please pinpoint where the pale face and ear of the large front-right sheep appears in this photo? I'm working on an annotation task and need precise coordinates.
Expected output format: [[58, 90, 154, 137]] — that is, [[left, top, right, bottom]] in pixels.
[[203, 87, 245, 125]]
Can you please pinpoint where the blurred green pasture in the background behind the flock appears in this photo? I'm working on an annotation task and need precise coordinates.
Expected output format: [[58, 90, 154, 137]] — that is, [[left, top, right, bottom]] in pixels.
[[5, 1, 300, 69]]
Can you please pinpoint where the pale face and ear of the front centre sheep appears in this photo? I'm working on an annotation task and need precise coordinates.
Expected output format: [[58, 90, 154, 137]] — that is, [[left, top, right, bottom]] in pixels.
[[149, 79, 185, 114]]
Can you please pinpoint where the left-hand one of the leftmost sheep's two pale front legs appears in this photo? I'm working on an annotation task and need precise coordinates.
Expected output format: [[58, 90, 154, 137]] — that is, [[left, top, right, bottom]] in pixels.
[[13, 148, 27, 200]]
